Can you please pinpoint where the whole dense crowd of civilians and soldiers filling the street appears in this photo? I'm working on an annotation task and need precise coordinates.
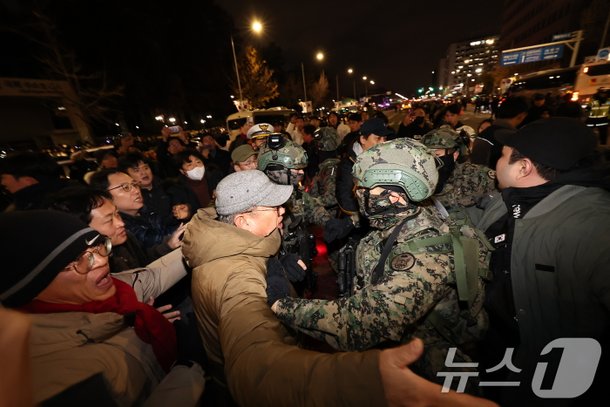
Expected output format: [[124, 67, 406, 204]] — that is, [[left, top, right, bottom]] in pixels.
[[0, 97, 610, 406]]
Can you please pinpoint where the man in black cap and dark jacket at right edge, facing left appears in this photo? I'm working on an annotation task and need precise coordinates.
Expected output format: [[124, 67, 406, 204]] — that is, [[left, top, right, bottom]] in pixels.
[[469, 117, 610, 406]]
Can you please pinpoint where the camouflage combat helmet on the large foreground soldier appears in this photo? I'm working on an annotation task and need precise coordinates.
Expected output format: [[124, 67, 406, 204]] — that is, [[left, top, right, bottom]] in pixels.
[[352, 138, 438, 202]]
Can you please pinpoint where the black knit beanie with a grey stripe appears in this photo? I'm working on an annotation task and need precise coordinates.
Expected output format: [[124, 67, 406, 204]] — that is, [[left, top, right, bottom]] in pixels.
[[0, 210, 99, 307]]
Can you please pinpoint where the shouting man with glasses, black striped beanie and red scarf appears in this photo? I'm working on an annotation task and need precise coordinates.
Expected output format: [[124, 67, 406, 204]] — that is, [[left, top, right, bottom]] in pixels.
[[0, 210, 205, 406]]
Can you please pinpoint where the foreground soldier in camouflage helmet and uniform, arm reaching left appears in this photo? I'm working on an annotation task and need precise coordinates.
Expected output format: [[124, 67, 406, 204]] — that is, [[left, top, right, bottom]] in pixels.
[[272, 138, 488, 381]]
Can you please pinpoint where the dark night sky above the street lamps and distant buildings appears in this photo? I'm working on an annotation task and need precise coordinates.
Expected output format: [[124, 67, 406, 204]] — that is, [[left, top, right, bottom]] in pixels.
[[218, 0, 503, 94]]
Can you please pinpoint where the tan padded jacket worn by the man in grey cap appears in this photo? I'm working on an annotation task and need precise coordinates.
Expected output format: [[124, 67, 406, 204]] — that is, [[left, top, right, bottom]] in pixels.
[[182, 208, 385, 406]]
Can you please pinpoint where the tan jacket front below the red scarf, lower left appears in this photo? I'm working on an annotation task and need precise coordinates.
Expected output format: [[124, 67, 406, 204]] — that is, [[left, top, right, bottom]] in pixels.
[[30, 312, 165, 406]]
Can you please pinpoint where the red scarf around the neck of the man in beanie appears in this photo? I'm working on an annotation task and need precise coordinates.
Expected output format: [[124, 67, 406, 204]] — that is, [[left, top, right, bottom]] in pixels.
[[21, 279, 177, 372]]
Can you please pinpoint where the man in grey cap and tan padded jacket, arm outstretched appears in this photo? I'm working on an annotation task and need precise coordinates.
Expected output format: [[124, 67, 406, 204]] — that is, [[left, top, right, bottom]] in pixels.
[[182, 170, 493, 406]]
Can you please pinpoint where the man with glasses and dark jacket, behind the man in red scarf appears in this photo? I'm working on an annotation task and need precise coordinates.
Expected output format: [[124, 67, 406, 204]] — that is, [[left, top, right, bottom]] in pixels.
[[90, 169, 185, 255]]
